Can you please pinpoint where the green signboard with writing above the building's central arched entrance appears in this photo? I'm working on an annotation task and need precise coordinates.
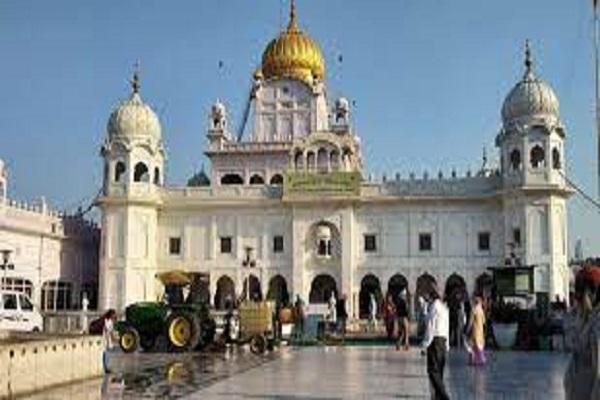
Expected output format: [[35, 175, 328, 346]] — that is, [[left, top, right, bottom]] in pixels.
[[283, 171, 361, 197]]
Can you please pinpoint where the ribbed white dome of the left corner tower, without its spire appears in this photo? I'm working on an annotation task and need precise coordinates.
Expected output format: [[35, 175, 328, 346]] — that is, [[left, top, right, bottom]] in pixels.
[[107, 91, 161, 140]]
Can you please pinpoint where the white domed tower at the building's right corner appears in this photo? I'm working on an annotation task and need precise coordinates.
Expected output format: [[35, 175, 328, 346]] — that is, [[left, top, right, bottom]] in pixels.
[[496, 41, 571, 299]]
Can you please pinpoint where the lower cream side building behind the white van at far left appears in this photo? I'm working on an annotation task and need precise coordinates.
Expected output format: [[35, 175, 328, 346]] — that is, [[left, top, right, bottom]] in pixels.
[[0, 160, 100, 311]]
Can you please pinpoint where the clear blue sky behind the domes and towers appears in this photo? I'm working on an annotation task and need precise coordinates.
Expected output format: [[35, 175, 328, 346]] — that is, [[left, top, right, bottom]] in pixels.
[[0, 0, 600, 254]]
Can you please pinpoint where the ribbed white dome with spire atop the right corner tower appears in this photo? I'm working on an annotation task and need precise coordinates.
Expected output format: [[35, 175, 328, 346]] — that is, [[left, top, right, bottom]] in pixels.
[[502, 42, 559, 127]]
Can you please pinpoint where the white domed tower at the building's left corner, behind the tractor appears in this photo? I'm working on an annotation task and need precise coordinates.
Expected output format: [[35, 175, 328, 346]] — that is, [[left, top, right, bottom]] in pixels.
[[98, 68, 165, 310]]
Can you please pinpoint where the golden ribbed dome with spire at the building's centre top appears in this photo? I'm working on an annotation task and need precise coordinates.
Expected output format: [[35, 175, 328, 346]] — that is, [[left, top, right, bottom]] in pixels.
[[261, 0, 325, 85]]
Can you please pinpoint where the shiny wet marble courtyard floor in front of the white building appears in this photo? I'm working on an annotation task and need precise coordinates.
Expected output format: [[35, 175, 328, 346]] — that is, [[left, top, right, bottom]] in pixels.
[[21, 346, 569, 400]]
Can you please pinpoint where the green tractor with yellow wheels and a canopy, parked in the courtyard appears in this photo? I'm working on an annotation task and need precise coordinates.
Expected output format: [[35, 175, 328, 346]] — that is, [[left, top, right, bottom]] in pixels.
[[116, 271, 216, 353]]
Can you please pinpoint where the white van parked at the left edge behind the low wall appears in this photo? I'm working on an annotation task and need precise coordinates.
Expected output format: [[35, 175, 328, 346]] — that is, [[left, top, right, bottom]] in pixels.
[[0, 290, 44, 332]]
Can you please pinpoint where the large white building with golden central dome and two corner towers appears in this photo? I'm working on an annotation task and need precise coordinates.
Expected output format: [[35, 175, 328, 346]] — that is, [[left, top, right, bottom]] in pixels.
[[98, 6, 571, 315]]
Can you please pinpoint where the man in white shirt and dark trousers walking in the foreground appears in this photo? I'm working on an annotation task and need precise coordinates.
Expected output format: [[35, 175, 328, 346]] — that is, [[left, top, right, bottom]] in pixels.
[[422, 288, 450, 400]]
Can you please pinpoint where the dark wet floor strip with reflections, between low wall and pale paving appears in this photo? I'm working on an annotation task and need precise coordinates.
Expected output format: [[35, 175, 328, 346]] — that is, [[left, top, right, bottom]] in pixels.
[[21, 348, 278, 400]]
